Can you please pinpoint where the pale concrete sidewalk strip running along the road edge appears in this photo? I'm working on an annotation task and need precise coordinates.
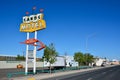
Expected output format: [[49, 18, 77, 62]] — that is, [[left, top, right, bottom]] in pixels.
[[10, 67, 104, 80]]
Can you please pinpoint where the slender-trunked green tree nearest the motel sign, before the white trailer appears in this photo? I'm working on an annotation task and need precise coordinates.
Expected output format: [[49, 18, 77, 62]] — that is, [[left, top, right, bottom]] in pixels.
[[44, 43, 58, 73]]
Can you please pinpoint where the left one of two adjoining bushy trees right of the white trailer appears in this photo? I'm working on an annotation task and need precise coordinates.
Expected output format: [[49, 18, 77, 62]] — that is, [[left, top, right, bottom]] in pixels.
[[74, 52, 84, 66]]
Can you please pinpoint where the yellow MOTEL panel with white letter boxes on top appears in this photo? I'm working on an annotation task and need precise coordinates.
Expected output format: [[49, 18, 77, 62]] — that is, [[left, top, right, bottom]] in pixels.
[[20, 14, 46, 32]]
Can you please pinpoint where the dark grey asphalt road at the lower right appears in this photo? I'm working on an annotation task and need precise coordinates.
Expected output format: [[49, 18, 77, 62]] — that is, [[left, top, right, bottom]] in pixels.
[[44, 66, 120, 80]]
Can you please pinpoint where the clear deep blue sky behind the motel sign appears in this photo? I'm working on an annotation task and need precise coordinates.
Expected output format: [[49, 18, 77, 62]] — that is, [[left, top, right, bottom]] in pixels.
[[0, 0, 120, 60]]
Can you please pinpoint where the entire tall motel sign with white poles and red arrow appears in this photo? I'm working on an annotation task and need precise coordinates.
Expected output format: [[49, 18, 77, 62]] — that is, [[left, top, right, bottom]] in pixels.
[[20, 7, 46, 75]]
